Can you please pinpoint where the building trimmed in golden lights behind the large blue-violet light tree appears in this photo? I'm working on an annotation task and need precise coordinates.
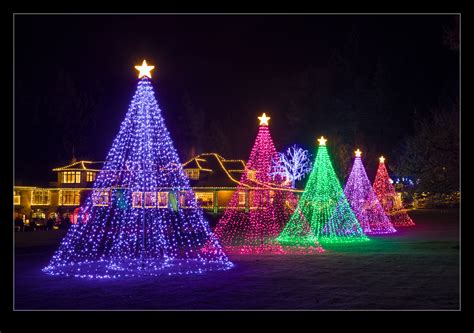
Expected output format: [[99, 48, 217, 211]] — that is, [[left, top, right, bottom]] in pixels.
[[13, 153, 248, 223]]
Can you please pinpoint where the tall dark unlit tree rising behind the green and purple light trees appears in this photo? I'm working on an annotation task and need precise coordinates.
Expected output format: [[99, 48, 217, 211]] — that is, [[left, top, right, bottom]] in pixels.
[[281, 28, 396, 180]]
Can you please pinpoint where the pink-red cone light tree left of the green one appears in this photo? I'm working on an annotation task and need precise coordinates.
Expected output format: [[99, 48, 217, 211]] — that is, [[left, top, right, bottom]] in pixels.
[[215, 113, 322, 254]]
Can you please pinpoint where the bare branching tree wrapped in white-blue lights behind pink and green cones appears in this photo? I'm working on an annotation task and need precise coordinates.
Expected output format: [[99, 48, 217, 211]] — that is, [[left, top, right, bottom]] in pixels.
[[270, 145, 312, 188]]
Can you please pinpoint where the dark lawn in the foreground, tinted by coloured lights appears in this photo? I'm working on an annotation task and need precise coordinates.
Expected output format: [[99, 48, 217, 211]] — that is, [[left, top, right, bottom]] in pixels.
[[14, 210, 459, 310]]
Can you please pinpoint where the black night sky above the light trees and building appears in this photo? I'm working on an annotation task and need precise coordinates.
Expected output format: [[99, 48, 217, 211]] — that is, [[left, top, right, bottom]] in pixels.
[[15, 15, 459, 184]]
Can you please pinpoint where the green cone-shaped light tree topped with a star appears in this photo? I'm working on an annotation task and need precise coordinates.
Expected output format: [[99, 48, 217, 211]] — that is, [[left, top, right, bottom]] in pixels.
[[278, 137, 368, 245]]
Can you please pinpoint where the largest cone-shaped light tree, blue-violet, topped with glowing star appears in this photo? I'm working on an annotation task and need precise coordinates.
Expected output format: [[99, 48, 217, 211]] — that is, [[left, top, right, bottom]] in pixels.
[[43, 61, 233, 278]]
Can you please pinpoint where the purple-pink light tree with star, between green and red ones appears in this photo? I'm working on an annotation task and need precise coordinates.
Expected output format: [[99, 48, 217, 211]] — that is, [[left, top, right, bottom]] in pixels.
[[344, 149, 396, 234]]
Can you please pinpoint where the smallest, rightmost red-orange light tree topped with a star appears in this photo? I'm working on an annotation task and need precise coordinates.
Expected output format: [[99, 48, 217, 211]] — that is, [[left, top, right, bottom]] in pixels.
[[373, 156, 415, 227]]
